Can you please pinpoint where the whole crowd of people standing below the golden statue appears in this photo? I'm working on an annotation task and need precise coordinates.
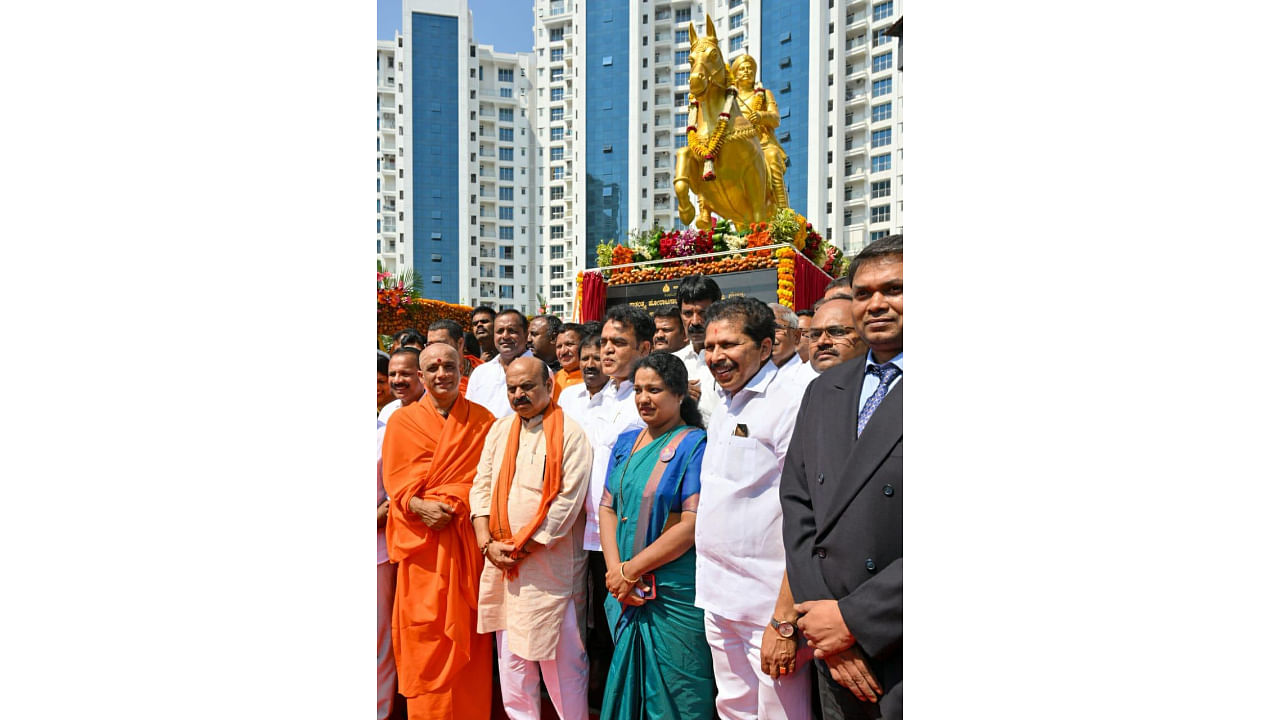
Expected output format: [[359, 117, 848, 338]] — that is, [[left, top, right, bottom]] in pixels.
[[378, 236, 902, 720]]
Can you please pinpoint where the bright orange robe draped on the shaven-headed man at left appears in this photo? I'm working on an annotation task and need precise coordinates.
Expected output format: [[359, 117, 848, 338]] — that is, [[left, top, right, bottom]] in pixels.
[[383, 395, 493, 720]]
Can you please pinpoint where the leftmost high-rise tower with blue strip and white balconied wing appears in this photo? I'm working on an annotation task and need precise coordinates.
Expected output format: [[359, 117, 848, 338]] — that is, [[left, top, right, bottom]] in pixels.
[[398, 0, 538, 313]]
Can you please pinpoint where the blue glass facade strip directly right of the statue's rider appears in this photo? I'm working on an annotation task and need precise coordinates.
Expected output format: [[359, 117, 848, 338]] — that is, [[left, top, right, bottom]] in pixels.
[[758, 0, 810, 217]]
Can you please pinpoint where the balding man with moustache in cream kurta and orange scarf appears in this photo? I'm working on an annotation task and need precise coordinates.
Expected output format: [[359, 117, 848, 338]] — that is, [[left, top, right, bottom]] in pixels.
[[471, 356, 591, 720]]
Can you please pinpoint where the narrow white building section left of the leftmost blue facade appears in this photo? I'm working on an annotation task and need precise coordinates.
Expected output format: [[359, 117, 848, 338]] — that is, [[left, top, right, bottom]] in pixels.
[[376, 40, 413, 273]]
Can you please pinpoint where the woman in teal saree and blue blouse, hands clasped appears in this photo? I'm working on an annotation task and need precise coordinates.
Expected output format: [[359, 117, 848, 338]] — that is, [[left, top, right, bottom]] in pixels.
[[600, 352, 716, 720]]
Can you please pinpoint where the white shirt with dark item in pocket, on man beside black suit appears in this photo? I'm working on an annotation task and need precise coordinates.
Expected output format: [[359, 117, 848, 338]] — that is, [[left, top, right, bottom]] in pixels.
[[694, 361, 803, 625]]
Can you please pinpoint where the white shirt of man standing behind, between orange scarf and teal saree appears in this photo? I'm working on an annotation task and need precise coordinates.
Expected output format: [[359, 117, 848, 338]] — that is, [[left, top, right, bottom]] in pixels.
[[576, 379, 645, 550]]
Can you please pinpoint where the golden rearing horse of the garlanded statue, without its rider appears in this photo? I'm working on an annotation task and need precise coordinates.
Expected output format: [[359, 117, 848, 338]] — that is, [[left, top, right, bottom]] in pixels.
[[672, 14, 785, 231]]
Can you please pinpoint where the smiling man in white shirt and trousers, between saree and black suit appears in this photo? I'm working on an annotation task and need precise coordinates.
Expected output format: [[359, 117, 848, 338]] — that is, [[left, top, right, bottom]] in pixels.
[[694, 297, 812, 720]]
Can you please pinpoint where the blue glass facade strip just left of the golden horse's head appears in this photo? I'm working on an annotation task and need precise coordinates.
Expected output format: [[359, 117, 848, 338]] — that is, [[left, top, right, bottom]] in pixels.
[[580, 0, 631, 268]]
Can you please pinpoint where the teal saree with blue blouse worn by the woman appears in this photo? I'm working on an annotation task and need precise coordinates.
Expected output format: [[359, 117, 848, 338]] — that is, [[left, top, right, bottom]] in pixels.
[[600, 425, 716, 720]]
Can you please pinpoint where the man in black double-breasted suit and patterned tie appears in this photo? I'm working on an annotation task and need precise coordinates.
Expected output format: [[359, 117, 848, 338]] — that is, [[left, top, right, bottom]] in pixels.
[[780, 234, 902, 720]]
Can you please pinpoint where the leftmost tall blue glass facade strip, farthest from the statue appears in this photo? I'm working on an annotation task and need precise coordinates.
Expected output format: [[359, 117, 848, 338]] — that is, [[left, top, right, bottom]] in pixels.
[[410, 13, 466, 302]]
